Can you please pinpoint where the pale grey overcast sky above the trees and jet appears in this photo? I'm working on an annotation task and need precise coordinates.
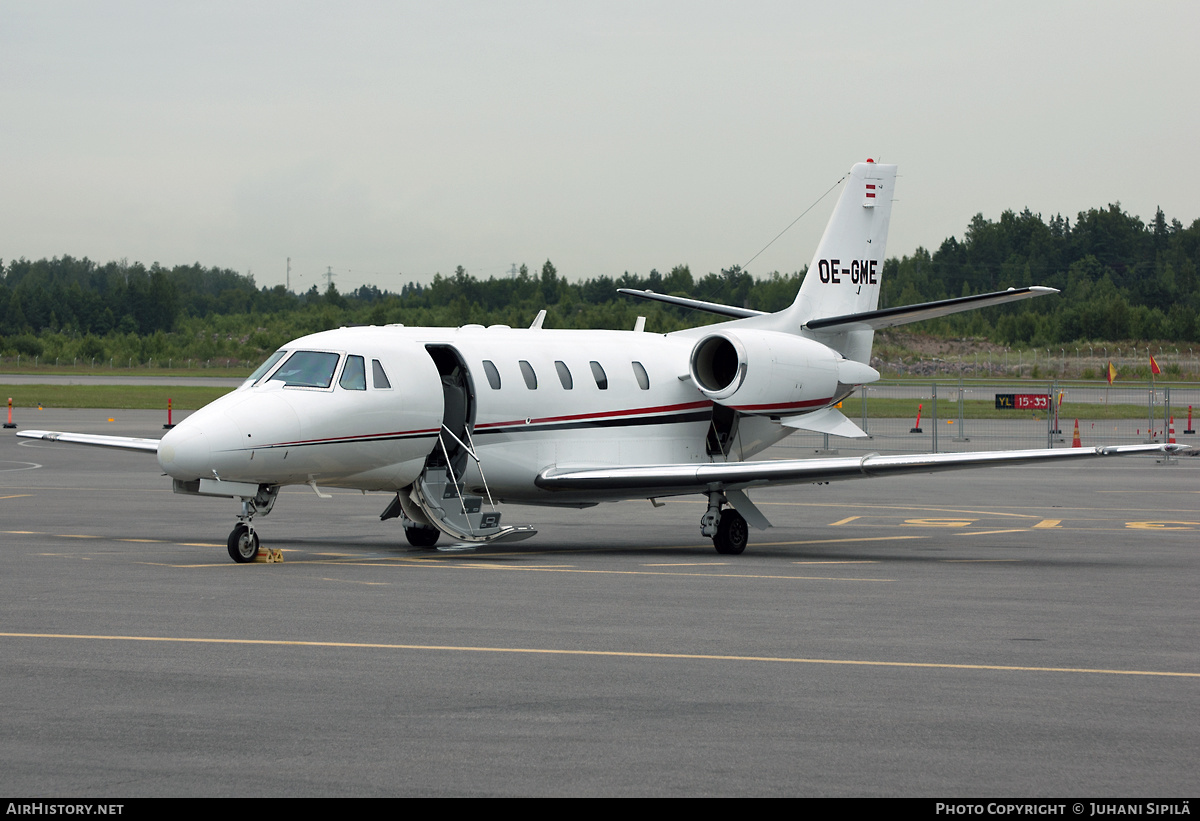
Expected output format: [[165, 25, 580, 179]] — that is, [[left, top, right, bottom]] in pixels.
[[0, 0, 1200, 290]]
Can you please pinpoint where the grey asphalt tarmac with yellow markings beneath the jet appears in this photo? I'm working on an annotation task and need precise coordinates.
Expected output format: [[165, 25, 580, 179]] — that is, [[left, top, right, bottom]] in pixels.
[[0, 411, 1200, 798]]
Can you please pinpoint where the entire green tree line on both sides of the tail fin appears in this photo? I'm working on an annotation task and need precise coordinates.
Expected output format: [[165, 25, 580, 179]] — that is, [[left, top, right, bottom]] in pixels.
[[0, 204, 1200, 364]]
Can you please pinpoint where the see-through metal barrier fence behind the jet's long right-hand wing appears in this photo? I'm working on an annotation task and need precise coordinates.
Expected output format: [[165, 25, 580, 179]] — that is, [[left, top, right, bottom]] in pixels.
[[776, 379, 1200, 457]]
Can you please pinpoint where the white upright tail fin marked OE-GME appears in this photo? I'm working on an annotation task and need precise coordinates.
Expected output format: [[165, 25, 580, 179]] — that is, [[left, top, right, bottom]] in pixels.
[[781, 160, 896, 362]]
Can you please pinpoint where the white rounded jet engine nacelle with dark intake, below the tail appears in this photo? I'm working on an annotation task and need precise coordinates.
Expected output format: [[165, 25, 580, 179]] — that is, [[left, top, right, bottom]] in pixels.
[[689, 330, 880, 417]]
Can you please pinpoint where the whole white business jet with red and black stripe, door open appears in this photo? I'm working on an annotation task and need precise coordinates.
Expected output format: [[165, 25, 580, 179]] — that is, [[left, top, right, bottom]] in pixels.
[[18, 160, 1168, 562]]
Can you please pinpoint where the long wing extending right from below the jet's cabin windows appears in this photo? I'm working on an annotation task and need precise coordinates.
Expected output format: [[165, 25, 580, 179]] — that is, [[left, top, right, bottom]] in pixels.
[[535, 444, 1188, 498]]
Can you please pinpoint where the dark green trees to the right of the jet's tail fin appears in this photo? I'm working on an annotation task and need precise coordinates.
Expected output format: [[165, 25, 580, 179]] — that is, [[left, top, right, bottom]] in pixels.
[[882, 204, 1200, 347]]
